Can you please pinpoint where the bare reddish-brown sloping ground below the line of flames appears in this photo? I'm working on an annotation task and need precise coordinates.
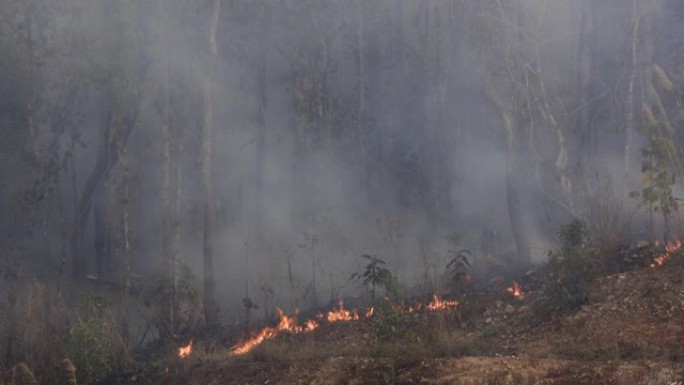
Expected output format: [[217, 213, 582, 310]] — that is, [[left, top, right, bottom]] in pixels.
[[154, 250, 684, 385]]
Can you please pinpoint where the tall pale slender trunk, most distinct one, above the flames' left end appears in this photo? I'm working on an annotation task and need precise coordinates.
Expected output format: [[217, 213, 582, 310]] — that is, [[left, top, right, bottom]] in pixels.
[[202, 0, 221, 326]]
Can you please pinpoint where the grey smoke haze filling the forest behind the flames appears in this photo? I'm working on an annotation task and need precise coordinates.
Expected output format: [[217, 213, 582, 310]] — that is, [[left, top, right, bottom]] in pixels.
[[0, 0, 684, 322]]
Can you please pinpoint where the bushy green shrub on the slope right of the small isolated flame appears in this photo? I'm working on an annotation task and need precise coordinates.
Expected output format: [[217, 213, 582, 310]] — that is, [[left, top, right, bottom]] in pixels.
[[544, 220, 600, 309]]
